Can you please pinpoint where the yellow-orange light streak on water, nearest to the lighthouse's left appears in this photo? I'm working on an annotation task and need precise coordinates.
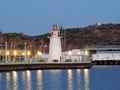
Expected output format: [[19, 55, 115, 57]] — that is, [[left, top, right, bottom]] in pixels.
[[37, 70, 43, 90]]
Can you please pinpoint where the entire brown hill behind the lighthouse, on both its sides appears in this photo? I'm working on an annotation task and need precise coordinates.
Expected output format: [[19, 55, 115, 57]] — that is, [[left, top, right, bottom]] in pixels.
[[0, 24, 120, 52]]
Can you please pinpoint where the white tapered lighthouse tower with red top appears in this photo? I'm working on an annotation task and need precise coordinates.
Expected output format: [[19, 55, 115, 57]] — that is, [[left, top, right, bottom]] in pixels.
[[48, 24, 62, 62]]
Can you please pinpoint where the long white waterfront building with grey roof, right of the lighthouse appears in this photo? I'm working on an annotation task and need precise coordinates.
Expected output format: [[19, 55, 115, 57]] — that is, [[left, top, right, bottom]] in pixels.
[[86, 45, 120, 61]]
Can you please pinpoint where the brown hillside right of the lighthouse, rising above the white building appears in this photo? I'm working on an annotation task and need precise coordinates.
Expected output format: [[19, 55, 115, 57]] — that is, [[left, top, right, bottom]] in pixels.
[[66, 24, 120, 49]]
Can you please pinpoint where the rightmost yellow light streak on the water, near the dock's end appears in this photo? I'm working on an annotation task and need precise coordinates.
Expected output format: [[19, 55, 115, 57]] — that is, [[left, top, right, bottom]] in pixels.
[[84, 69, 89, 90]]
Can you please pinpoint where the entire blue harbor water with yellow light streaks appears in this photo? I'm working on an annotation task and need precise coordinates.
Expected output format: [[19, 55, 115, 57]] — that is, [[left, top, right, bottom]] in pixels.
[[0, 66, 120, 90]]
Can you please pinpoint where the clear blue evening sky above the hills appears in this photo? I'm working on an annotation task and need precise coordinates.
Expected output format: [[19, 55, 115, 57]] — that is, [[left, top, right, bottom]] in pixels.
[[0, 0, 120, 36]]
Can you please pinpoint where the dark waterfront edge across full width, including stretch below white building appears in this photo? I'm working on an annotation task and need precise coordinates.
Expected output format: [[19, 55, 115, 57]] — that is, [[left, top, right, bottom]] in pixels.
[[0, 60, 120, 72]]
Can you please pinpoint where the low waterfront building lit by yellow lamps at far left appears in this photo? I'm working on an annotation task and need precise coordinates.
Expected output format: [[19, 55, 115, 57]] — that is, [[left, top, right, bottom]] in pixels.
[[0, 49, 30, 63]]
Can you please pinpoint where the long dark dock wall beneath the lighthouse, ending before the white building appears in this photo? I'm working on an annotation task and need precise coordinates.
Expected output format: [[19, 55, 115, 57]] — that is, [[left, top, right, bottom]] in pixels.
[[0, 62, 92, 71]]
